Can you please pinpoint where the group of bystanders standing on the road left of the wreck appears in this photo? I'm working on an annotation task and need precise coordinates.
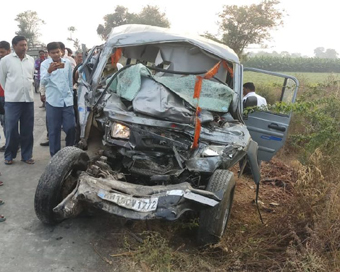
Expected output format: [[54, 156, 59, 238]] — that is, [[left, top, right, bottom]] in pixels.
[[0, 36, 82, 222]]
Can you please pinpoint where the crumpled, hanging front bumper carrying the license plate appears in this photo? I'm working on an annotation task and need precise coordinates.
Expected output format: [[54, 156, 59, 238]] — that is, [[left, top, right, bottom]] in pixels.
[[53, 172, 223, 220]]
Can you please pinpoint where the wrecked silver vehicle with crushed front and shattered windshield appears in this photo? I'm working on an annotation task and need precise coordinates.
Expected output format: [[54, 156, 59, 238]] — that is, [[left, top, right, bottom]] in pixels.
[[35, 25, 295, 244]]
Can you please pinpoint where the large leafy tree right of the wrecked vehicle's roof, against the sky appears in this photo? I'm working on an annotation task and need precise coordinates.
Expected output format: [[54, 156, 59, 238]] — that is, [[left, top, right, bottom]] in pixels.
[[205, 0, 284, 57]]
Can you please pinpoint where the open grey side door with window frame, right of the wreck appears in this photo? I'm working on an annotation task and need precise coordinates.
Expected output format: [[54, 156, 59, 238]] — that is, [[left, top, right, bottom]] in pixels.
[[242, 67, 299, 161]]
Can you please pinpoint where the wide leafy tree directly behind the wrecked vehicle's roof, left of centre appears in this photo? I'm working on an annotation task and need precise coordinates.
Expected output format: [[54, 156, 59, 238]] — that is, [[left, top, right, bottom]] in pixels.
[[97, 5, 170, 40]]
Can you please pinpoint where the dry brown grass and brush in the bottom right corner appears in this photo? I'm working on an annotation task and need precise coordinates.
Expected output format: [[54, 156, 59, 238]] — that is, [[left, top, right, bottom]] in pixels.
[[194, 150, 340, 271]]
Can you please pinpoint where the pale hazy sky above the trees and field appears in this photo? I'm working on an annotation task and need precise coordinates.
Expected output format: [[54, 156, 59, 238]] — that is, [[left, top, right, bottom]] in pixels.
[[0, 0, 340, 57]]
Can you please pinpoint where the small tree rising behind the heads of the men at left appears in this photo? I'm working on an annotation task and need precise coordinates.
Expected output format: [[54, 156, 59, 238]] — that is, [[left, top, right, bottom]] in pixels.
[[15, 10, 45, 46]]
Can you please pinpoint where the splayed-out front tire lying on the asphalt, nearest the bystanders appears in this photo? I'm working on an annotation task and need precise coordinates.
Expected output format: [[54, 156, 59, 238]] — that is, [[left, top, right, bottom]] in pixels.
[[34, 146, 90, 224]]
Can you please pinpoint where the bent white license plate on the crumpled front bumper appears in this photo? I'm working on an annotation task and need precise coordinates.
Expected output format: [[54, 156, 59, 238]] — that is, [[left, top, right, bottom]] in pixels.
[[98, 190, 158, 212]]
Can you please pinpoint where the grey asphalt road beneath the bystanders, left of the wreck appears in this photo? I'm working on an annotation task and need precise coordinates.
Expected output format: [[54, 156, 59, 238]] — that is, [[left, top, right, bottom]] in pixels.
[[0, 94, 122, 272]]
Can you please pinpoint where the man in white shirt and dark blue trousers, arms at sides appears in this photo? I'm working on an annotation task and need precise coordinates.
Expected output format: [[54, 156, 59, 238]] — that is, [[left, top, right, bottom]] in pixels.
[[0, 36, 34, 165]]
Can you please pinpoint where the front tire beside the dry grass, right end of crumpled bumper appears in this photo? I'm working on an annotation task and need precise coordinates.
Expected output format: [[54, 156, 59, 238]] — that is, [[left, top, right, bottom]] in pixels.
[[197, 170, 236, 245]]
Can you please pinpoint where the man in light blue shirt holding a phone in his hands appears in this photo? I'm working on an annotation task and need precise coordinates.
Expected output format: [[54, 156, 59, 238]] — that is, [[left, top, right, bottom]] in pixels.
[[41, 42, 75, 156]]
